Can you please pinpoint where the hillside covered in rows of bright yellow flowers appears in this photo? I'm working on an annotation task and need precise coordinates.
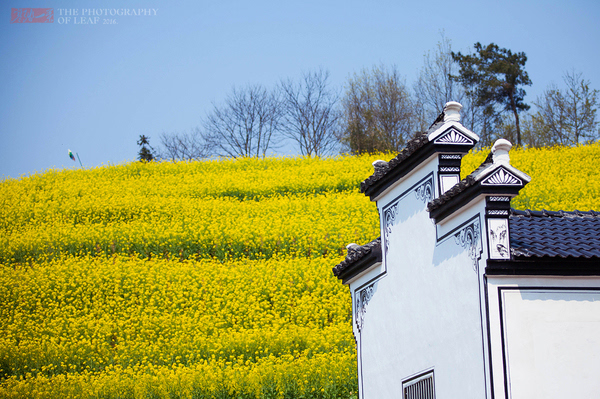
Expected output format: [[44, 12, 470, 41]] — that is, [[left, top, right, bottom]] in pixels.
[[0, 144, 600, 398]]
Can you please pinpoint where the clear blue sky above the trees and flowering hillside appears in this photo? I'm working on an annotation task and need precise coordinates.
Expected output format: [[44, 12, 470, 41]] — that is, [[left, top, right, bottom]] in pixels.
[[0, 0, 600, 179]]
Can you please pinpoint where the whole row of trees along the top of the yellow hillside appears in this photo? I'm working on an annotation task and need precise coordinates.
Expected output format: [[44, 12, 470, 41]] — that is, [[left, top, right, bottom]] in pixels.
[[138, 34, 600, 160]]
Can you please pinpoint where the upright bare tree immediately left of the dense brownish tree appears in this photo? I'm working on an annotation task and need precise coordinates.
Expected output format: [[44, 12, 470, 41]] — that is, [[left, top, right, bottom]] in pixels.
[[279, 69, 339, 156]]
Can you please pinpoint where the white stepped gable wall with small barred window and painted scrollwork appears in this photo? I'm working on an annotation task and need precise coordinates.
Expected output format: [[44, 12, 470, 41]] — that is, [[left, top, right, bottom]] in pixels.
[[351, 159, 486, 399]]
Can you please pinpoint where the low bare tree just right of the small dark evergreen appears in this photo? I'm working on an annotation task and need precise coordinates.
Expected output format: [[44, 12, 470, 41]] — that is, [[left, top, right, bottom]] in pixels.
[[159, 127, 212, 160]]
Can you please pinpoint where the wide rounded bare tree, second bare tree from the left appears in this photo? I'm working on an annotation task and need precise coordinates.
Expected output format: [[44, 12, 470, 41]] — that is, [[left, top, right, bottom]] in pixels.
[[204, 85, 281, 158]]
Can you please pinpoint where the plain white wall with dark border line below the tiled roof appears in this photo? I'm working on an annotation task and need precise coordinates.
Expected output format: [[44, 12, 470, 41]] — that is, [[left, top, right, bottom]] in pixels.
[[488, 276, 600, 399]]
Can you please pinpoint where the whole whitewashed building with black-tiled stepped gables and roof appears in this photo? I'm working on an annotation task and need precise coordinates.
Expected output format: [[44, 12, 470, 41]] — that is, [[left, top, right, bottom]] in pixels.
[[333, 102, 600, 399]]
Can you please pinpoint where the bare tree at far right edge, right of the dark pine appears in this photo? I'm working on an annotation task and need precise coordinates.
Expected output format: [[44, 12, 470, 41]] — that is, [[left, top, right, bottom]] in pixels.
[[532, 71, 600, 145]]
